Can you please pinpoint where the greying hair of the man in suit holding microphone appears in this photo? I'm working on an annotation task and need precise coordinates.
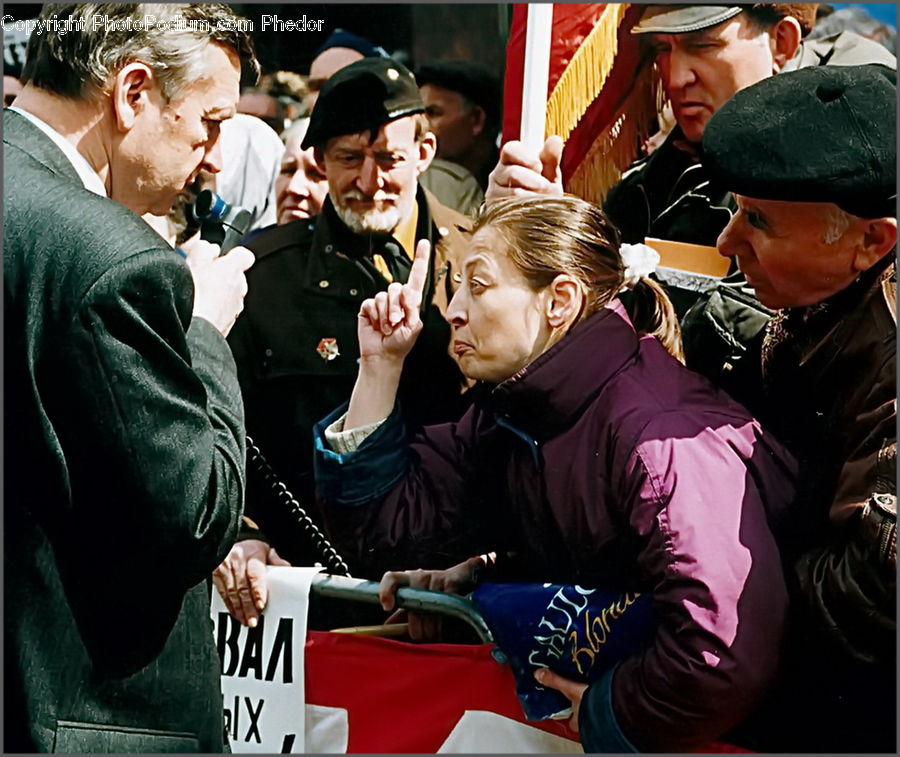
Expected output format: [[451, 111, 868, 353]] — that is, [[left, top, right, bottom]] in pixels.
[[22, 3, 259, 100]]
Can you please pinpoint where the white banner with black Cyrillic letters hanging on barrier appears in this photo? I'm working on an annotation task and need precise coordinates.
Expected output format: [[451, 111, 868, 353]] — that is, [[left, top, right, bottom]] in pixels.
[[210, 567, 321, 754]]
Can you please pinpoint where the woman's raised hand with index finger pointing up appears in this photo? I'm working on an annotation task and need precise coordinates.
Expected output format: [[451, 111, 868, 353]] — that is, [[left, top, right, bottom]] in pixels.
[[357, 239, 431, 361]]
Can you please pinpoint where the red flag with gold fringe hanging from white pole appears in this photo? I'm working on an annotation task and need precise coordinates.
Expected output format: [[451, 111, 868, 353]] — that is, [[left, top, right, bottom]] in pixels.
[[503, 3, 659, 202]]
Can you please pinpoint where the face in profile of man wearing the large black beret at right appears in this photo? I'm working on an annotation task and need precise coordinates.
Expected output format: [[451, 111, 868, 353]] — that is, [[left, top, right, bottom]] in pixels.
[[717, 195, 860, 308]]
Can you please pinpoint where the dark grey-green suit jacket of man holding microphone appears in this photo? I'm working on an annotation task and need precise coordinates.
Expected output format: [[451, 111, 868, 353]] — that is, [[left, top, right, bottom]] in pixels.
[[3, 111, 244, 752]]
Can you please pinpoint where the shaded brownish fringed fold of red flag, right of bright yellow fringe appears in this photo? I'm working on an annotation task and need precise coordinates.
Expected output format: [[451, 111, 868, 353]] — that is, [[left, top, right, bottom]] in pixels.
[[566, 66, 665, 204]]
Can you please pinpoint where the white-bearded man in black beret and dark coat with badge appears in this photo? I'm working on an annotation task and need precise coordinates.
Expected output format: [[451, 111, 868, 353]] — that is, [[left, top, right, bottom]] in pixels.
[[216, 57, 469, 621]]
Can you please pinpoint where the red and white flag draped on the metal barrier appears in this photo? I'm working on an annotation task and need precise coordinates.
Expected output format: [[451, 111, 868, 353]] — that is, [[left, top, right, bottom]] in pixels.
[[305, 631, 745, 754]]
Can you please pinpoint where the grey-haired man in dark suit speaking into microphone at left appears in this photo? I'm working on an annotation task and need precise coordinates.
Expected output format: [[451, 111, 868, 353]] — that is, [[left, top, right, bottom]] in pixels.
[[3, 5, 255, 752]]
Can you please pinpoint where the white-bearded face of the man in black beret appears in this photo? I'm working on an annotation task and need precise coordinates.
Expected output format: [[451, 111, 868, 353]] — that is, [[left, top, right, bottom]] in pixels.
[[323, 116, 434, 233]]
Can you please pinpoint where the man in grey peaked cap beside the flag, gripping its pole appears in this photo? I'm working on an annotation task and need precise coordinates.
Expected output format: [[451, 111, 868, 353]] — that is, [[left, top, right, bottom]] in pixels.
[[487, 3, 896, 245]]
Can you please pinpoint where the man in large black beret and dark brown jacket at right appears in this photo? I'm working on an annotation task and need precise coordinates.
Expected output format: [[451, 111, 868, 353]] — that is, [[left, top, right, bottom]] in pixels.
[[703, 65, 897, 752]]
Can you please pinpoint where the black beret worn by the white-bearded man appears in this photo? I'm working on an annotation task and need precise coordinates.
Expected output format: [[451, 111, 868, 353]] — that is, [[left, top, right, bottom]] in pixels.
[[301, 58, 425, 150]]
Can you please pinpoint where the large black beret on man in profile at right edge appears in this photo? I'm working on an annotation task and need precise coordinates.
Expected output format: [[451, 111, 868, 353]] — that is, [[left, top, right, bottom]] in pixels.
[[703, 64, 897, 218]]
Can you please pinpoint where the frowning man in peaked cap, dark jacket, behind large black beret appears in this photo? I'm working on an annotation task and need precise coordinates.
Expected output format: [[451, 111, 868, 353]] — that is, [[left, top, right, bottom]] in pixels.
[[486, 3, 896, 404]]
